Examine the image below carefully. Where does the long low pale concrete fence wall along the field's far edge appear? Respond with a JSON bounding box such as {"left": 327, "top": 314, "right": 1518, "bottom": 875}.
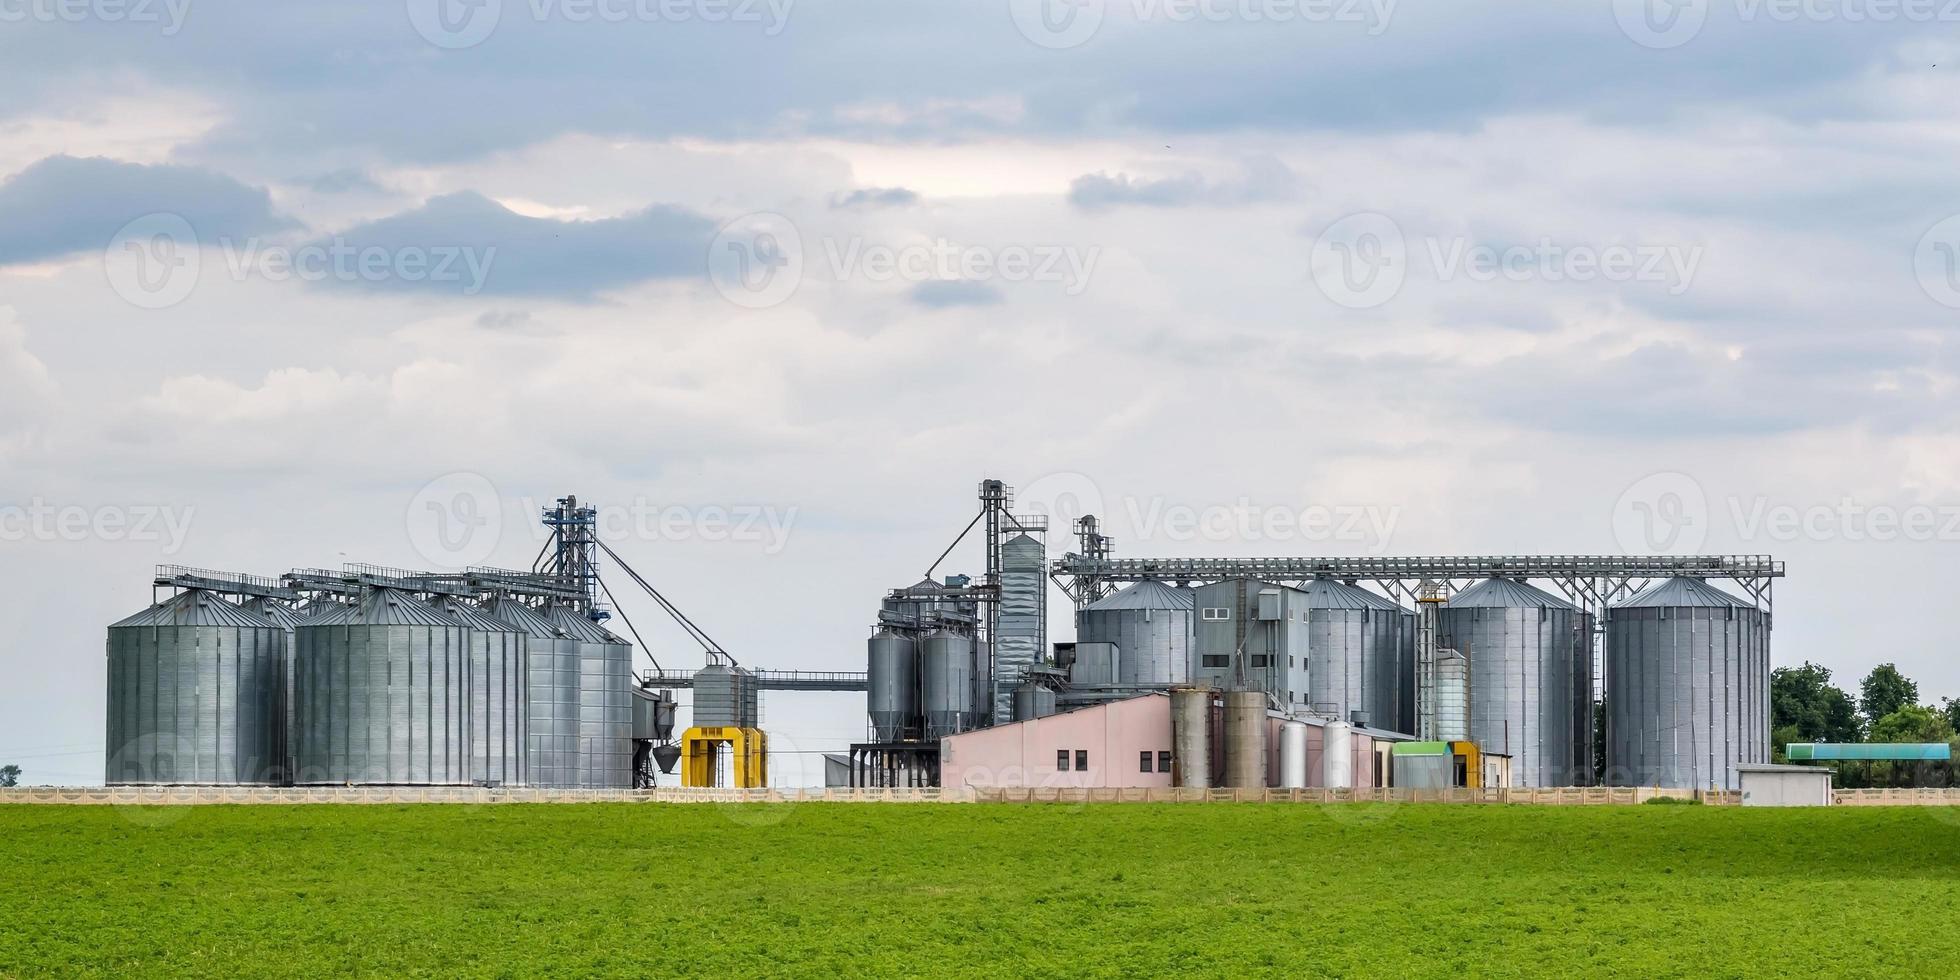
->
{"left": 0, "top": 786, "right": 1748, "bottom": 806}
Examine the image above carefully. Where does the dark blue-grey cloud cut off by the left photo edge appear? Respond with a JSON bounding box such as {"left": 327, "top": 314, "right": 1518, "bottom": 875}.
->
{"left": 0, "top": 157, "right": 288, "bottom": 265}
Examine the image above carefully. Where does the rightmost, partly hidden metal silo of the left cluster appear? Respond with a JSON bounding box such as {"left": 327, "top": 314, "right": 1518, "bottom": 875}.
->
{"left": 545, "top": 604, "right": 633, "bottom": 790}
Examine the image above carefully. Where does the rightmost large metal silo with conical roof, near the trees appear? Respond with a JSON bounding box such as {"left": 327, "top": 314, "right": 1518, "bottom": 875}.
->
{"left": 1605, "top": 578, "right": 1770, "bottom": 790}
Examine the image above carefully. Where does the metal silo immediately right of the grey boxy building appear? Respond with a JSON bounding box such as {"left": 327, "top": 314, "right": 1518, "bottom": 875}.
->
{"left": 1299, "top": 578, "right": 1413, "bottom": 731}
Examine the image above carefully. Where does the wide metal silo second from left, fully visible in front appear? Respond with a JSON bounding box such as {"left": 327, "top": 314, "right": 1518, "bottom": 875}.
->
{"left": 292, "top": 588, "right": 470, "bottom": 786}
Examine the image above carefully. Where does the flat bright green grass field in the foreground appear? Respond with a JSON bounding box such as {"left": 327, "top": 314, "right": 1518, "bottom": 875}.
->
{"left": 0, "top": 804, "right": 1960, "bottom": 976}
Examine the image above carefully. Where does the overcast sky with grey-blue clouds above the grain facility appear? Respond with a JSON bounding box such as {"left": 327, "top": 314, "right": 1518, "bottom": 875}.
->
{"left": 0, "top": 0, "right": 1960, "bottom": 784}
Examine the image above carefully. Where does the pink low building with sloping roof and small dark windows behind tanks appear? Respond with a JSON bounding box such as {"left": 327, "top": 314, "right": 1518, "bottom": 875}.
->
{"left": 939, "top": 694, "right": 1396, "bottom": 788}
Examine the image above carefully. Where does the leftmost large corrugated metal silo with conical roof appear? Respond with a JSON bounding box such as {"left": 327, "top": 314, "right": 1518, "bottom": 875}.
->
{"left": 104, "top": 590, "right": 286, "bottom": 786}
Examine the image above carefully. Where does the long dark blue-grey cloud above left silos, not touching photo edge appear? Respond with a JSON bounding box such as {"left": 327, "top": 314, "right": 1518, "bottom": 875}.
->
{"left": 317, "top": 192, "right": 715, "bottom": 300}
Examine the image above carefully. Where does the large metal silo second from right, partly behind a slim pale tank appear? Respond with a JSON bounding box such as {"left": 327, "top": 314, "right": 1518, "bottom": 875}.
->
{"left": 1441, "top": 578, "right": 1580, "bottom": 786}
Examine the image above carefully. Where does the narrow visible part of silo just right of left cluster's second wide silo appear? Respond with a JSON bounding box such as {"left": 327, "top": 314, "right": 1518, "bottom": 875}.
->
{"left": 433, "top": 598, "right": 531, "bottom": 786}
